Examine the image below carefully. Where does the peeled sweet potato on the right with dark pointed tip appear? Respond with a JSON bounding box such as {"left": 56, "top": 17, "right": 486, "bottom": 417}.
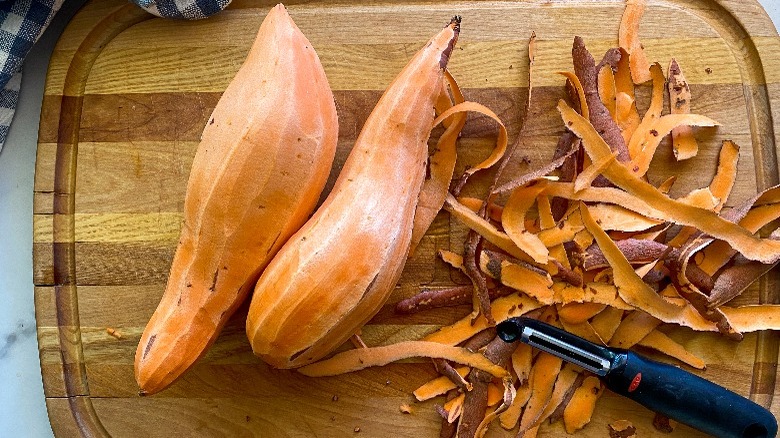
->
{"left": 247, "top": 17, "right": 460, "bottom": 368}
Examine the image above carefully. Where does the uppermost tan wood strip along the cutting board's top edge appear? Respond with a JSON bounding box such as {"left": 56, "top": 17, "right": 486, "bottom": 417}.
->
{"left": 80, "top": 1, "right": 718, "bottom": 49}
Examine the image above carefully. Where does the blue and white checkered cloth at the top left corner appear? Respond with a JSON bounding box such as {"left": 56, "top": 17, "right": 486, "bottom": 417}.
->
{"left": 0, "top": 0, "right": 230, "bottom": 150}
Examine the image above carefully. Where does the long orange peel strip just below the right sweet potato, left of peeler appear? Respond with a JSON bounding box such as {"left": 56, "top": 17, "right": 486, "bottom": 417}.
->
{"left": 298, "top": 341, "right": 509, "bottom": 378}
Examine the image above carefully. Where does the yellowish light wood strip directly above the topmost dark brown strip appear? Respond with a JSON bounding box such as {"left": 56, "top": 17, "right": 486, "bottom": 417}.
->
{"left": 65, "top": 37, "right": 742, "bottom": 94}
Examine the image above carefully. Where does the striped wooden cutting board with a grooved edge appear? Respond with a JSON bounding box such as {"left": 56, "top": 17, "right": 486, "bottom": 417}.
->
{"left": 33, "top": 0, "right": 780, "bottom": 437}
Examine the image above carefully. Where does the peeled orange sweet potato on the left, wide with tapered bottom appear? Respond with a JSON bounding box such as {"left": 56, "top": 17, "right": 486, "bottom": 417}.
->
{"left": 135, "top": 5, "right": 338, "bottom": 393}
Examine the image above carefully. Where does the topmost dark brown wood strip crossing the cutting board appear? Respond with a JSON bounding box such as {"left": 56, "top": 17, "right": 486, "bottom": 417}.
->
{"left": 39, "top": 84, "right": 748, "bottom": 142}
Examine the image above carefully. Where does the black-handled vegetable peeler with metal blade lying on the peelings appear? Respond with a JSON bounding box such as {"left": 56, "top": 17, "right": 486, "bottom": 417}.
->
{"left": 497, "top": 317, "right": 777, "bottom": 438}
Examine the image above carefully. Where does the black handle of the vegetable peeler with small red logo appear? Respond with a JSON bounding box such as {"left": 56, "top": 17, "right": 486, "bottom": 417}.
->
{"left": 602, "top": 349, "right": 777, "bottom": 438}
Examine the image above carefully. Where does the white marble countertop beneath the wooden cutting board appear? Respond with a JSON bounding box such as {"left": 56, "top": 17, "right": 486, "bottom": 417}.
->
{"left": 0, "top": 0, "right": 780, "bottom": 437}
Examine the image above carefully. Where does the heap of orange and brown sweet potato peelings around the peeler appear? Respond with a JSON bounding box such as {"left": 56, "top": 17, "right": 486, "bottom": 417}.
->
{"left": 301, "top": 2, "right": 780, "bottom": 437}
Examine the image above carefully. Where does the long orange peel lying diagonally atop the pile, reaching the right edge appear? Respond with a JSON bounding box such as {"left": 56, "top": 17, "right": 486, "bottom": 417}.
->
{"left": 548, "top": 101, "right": 780, "bottom": 264}
